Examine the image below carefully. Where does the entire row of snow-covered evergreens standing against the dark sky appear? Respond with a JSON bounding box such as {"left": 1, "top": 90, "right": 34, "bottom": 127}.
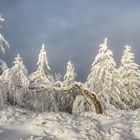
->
{"left": 0, "top": 15, "right": 140, "bottom": 109}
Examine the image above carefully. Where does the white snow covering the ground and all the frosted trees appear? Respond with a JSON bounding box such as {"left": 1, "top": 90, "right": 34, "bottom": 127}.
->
{"left": 0, "top": 14, "right": 140, "bottom": 140}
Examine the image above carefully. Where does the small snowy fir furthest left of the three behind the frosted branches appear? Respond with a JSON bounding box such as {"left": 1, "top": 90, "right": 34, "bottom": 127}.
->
{"left": 0, "top": 54, "right": 29, "bottom": 105}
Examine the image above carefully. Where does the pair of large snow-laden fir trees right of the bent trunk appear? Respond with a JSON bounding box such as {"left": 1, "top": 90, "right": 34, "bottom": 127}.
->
{"left": 86, "top": 39, "right": 140, "bottom": 109}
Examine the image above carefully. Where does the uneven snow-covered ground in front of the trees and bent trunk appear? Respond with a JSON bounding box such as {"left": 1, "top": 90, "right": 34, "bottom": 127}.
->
{"left": 0, "top": 107, "right": 140, "bottom": 140}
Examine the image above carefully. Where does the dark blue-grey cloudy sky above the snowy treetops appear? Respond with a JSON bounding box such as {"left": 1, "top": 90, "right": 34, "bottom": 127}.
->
{"left": 0, "top": 0, "right": 140, "bottom": 81}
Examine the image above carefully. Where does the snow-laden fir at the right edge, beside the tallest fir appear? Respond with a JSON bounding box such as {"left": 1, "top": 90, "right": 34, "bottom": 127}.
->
{"left": 119, "top": 46, "right": 140, "bottom": 108}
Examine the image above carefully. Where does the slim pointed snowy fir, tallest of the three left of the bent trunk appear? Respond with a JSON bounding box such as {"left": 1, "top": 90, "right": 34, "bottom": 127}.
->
{"left": 29, "top": 44, "right": 52, "bottom": 84}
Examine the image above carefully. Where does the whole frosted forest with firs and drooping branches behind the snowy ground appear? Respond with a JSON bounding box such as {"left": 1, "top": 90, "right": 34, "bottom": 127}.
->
{"left": 0, "top": 15, "right": 140, "bottom": 112}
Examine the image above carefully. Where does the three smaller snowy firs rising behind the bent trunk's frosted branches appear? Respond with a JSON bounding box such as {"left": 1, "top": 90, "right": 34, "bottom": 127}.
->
{"left": 0, "top": 44, "right": 76, "bottom": 89}
